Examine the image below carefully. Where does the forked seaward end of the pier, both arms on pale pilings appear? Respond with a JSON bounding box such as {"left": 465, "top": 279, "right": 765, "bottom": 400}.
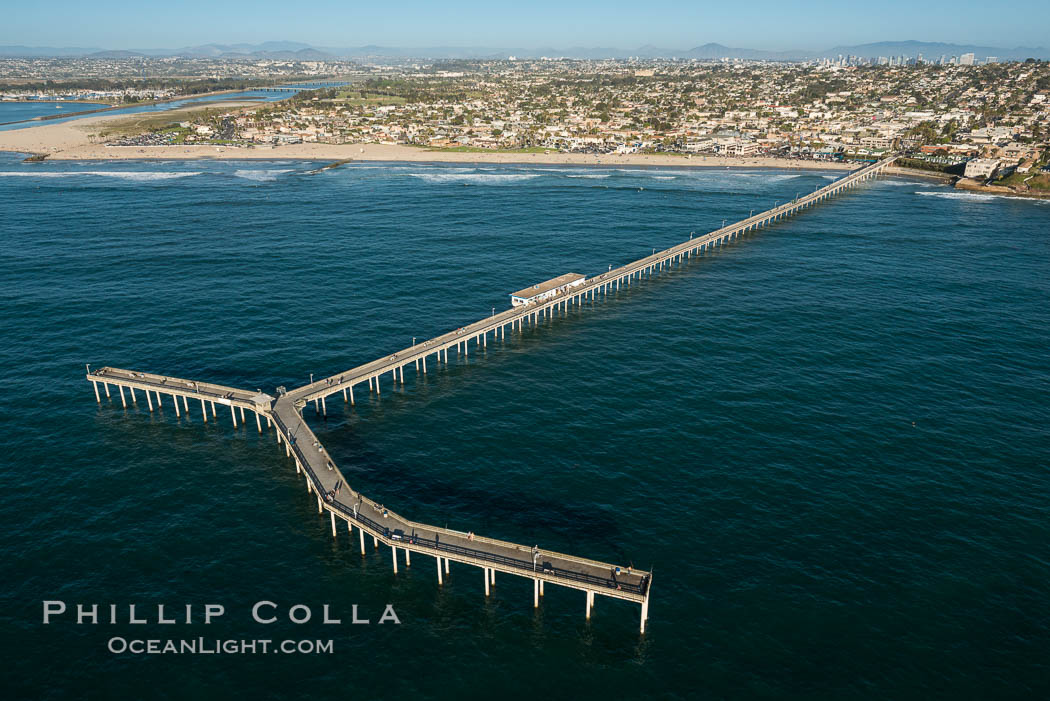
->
{"left": 86, "top": 367, "right": 652, "bottom": 632}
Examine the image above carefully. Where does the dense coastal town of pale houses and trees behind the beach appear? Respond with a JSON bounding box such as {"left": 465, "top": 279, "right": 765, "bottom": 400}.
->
{"left": 4, "top": 56, "right": 1050, "bottom": 193}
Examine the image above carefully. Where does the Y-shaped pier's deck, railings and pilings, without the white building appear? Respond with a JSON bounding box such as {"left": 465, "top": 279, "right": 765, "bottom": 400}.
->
{"left": 87, "top": 156, "right": 895, "bottom": 633}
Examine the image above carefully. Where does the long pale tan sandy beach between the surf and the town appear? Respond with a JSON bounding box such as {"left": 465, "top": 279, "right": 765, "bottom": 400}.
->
{"left": 0, "top": 103, "right": 865, "bottom": 170}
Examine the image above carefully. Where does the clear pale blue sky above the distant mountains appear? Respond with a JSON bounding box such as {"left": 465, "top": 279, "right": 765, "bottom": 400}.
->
{"left": 8, "top": 0, "right": 1050, "bottom": 50}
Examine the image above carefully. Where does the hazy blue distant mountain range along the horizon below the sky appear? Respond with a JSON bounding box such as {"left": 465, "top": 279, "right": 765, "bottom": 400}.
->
{"left": 0, "top": 41, "right": 1050, "bottom": 61}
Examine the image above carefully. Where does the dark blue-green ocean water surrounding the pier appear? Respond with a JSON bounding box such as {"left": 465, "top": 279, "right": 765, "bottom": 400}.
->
{"left": 0, "top": 154, "right": 1050, "bottom": 699}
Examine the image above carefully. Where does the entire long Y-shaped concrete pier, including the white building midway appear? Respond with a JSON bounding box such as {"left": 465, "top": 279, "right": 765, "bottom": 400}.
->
{"left": 86, "top": 156, "right": 896, "bottom": 633}
